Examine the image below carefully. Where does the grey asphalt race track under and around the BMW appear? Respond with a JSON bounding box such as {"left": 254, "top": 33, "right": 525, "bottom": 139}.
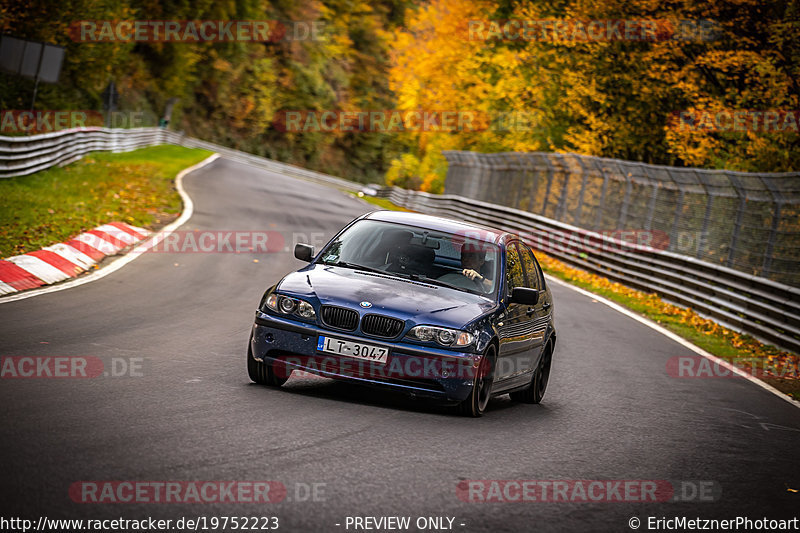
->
{"left": 0, "top": 156, "right": 800, "bottom": 532}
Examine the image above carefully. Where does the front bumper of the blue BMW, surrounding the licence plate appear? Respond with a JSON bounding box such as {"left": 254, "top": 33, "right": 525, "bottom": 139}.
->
{"left": 250, "top": 311, "right": 480, "bottom": 403}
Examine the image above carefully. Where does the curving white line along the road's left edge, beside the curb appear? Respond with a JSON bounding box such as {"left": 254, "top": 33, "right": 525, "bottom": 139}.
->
{"left": 0, "top": 154, "right": 219, "bottom": 304}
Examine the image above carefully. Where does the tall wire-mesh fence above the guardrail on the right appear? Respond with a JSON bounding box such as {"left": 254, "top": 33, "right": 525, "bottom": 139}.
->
{"left": 443, "top": 151, "right": 800, "bottom": 286}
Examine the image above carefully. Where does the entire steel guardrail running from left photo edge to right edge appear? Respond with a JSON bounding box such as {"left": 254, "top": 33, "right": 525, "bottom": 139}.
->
{"left": 0, "top": 128, "right": 800, "bottom": 353}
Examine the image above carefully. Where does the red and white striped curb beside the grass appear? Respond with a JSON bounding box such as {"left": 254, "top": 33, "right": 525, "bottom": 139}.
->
{"left": 0, "top": 222, "right": 151, "bottom": 295}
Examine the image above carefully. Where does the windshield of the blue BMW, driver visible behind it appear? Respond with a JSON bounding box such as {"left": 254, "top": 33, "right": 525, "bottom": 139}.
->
{"left": 319, "top": 220, "right": 500, "bottom": 295}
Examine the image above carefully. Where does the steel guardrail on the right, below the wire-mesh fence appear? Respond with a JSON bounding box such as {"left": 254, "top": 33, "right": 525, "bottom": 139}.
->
{"left": 378, "top": 187, "right": 800, "bottom": 353}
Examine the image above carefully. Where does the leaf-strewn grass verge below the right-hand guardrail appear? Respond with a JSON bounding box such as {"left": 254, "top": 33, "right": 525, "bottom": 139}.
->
{"left": 363, "top": 191, "right": 800, "bottom": 400}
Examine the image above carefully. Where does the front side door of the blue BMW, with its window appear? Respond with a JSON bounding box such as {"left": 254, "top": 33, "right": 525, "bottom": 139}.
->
{"left": 495, "top": 242, "right": 536, "bottom": 381}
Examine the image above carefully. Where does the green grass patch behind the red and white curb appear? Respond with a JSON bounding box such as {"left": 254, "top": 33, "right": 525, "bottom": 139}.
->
{"left": 0, "top": 145, "right": 211, "bottom": 257}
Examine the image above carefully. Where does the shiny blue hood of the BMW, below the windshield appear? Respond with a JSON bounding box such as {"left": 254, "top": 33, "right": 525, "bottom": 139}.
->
{"left": 277, "top": 265, "right": 497, "bottom": 328}
